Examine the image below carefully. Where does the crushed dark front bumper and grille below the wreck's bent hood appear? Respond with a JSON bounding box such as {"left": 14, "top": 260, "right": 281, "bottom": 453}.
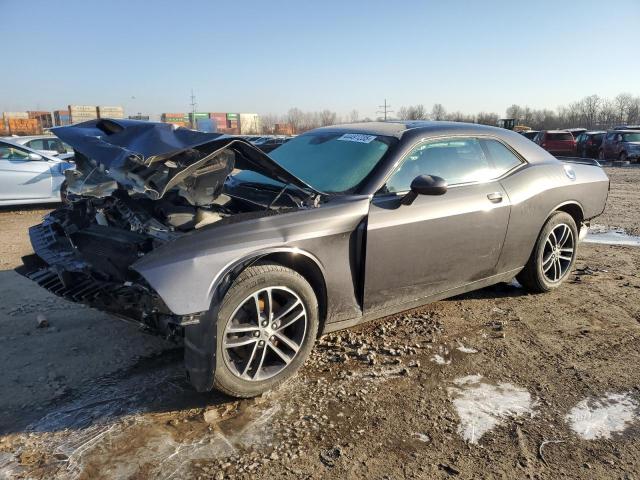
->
{"left": 18, "top": 202, "right": 198, "bottom": 335}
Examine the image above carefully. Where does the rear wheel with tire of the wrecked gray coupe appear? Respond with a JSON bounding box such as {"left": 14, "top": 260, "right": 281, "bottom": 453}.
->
{"left": 516, "top": 212, "right": 578, "bottom": 293}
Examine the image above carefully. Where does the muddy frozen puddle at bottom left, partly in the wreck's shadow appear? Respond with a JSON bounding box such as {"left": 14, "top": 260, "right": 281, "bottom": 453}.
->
{"left": 0, "top": 348, "right": 279, "bottom": 479}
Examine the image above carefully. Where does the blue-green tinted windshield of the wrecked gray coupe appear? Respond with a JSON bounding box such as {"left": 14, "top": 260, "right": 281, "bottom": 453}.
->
{"left": 234, "top": 132, "right": 395, "bottom": 193}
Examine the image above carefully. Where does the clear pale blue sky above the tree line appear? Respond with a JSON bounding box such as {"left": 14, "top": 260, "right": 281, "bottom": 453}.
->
{"left": 0, "top": 0, "right": 640, "bottom": 117}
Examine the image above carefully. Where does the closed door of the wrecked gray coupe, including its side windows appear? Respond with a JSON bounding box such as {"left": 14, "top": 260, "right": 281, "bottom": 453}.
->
{"left": 364, "top": 137, "right": 522, "bottom": 313}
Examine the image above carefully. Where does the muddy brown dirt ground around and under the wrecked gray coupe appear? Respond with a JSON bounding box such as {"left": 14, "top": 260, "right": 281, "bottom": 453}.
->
{"left": 0, "top": 168, "right": 640, "bottom": 479}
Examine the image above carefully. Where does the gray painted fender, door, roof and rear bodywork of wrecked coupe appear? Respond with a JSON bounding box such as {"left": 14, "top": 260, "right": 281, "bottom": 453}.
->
{"left": 132, "top": 122, "right": 609, "bottom": 329}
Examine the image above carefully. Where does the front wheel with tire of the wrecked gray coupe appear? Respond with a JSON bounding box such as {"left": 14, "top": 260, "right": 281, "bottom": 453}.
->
{"left": 214, "top": 264, "right": 318, "bottom": 397}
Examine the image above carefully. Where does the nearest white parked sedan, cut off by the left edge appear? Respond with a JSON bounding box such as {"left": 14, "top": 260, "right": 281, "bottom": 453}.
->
{"left": 0, "top": 140, "right": 73, "bottom": 205}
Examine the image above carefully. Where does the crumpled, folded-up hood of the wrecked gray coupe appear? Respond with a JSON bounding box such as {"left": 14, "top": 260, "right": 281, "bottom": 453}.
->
{"left": 52, "top": 119, "right": 313, "bottom": 200}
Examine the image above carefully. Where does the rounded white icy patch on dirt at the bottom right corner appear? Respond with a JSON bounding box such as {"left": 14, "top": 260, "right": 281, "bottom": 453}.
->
{"left": 565, "top": 393, "right": 640, "bottom": 440}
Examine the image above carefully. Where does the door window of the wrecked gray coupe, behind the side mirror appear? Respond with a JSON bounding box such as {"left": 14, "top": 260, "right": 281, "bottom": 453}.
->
{"left": 384, "top": 137, "right": 496, "bottom": 192}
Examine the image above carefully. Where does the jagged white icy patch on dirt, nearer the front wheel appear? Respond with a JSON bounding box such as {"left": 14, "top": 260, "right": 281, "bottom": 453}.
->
{"left": 447, "top": 375, "right": 535, "bottom": 443}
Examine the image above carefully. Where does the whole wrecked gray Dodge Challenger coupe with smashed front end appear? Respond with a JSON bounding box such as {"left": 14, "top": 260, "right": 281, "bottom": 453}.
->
{"left": 21, "top": 120, "right": 609, "bottom": 397}
